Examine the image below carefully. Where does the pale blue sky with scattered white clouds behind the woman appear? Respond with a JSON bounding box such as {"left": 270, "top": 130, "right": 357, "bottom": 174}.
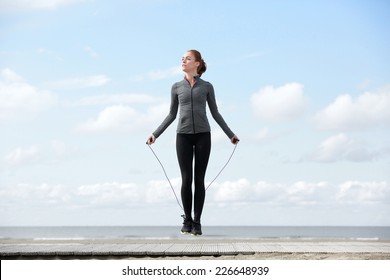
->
{"left": 0, "top": 0, "right": 390, "bottom": 226}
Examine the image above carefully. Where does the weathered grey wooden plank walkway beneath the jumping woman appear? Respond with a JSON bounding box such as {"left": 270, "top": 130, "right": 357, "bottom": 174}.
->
{"left": 0, "top": 240, "right": 390, "bottom": 258}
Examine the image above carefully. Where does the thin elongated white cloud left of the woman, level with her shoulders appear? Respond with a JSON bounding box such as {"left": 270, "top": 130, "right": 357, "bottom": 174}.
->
{"left": 47, "top": 75, "right": 111, "bottom": 89}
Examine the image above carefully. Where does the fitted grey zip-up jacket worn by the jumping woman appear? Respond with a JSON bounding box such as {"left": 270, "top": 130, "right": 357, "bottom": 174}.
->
{"left": 153, "top": 77, "right": 234, "bottom": 139}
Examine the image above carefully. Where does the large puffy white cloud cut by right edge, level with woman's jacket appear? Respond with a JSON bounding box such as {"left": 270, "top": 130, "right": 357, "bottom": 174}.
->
{"left": 314, "top": 86, "right": 390, "bottom": 130}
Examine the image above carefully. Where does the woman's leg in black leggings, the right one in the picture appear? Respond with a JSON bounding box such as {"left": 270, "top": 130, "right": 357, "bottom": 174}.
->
{"left": 194, "top": 132, "right": 211, "bottom": 223}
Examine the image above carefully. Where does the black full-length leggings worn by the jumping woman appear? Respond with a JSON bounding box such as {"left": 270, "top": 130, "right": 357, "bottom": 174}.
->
{"left": 176, "top": 132, "right": 211, "bottom": 222}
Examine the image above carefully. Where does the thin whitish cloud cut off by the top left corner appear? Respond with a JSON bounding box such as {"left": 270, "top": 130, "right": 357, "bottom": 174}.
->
{"left": 0, "top": 0, "right": 86, "bottom": 11}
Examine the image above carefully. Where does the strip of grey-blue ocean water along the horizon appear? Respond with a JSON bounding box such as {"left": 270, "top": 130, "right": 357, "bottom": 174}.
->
{"left": 0, "top": 226, "right": 390, "bottom": 242}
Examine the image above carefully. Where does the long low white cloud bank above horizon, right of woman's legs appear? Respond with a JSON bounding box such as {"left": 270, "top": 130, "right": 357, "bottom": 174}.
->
{"left": 212, "top": 179, "right": 390, "bottom": 207}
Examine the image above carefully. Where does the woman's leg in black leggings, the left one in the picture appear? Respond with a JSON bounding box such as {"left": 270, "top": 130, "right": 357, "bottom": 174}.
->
{"left": 176, "top": 133, "right": 194, "bottom": 221}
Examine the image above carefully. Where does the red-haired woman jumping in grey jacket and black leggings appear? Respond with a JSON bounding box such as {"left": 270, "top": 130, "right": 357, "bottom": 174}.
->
{"left": 148, "top": 50, "right": 239, "bottom": 235}
